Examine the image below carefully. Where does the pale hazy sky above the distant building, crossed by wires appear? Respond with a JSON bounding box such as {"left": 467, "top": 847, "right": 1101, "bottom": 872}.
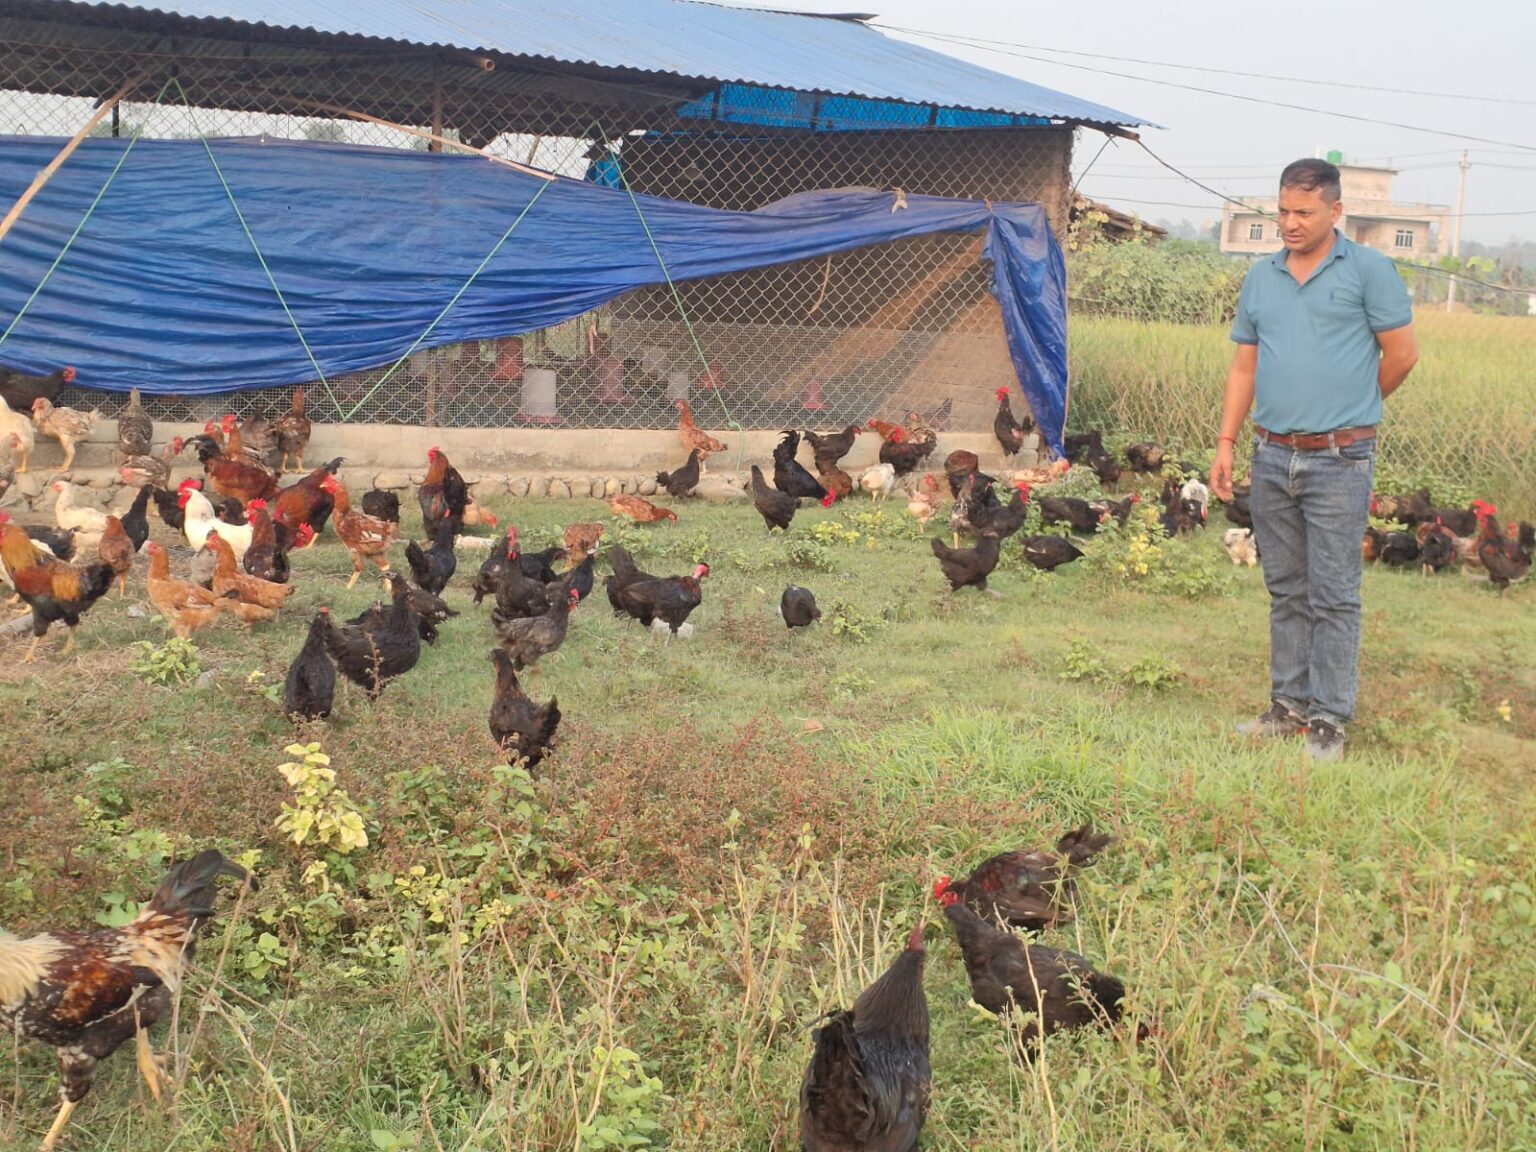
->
{"left": 754, "top": 0, "right": 1536, "bottom": 243}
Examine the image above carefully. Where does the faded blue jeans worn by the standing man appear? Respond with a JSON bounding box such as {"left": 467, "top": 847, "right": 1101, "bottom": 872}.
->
{"left": 1249, "top": 439, "right": 1376, "bottom": 728}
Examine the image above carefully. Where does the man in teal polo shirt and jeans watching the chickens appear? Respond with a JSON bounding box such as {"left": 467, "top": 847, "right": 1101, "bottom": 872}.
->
{"left": 1210, "top": 160, "right": 1419, "bottom": 760}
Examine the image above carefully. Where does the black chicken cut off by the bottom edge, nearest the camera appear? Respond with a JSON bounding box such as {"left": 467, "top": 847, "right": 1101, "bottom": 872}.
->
{"left": 800, "top": 923, "right": 932, "bottom": 1152}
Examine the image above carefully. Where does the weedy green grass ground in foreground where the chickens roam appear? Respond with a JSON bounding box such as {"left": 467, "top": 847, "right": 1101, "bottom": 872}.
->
{"left": 0, "top": 501, "right": 1536, "bottom": 1152}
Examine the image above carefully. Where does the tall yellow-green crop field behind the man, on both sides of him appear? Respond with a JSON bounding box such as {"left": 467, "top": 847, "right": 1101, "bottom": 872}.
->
{"left": 1069, "top": 309, "right": 1536, "bottom": 518}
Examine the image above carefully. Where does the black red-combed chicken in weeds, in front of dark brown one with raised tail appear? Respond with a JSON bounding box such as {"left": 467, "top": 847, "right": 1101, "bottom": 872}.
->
{"left": 942, "top": 892, "right": 1126, "bottom": 1054}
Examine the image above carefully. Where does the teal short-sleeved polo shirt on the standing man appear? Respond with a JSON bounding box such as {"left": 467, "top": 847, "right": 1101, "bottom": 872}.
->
{"left": 1232, "top": 230, "right": 1413, "bottom": 433}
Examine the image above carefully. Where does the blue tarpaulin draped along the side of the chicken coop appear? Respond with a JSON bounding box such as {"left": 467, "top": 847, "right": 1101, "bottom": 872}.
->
{"left": 0, "top": 137, "right": 1066, "bottom": 450}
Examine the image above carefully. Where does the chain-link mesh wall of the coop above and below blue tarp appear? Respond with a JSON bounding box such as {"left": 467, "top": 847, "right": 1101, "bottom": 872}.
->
{"left": 0, "top": 0, "right": 1072, "bottom": 432}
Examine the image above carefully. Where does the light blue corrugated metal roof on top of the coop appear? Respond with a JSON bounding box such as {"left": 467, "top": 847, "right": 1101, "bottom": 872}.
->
{"left": 77, "top": 0, "right": 1149, "bottom": 126}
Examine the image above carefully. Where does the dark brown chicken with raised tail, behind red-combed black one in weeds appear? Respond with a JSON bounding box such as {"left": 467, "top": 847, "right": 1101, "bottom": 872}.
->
{"left": 934, "top": 823, "right": 1112, "bottom": 932}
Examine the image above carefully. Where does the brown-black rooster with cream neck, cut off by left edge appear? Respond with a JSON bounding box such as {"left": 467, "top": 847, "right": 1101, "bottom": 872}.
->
{"left": 0, "top": 849, "right": 250, "bottom": 1149}
